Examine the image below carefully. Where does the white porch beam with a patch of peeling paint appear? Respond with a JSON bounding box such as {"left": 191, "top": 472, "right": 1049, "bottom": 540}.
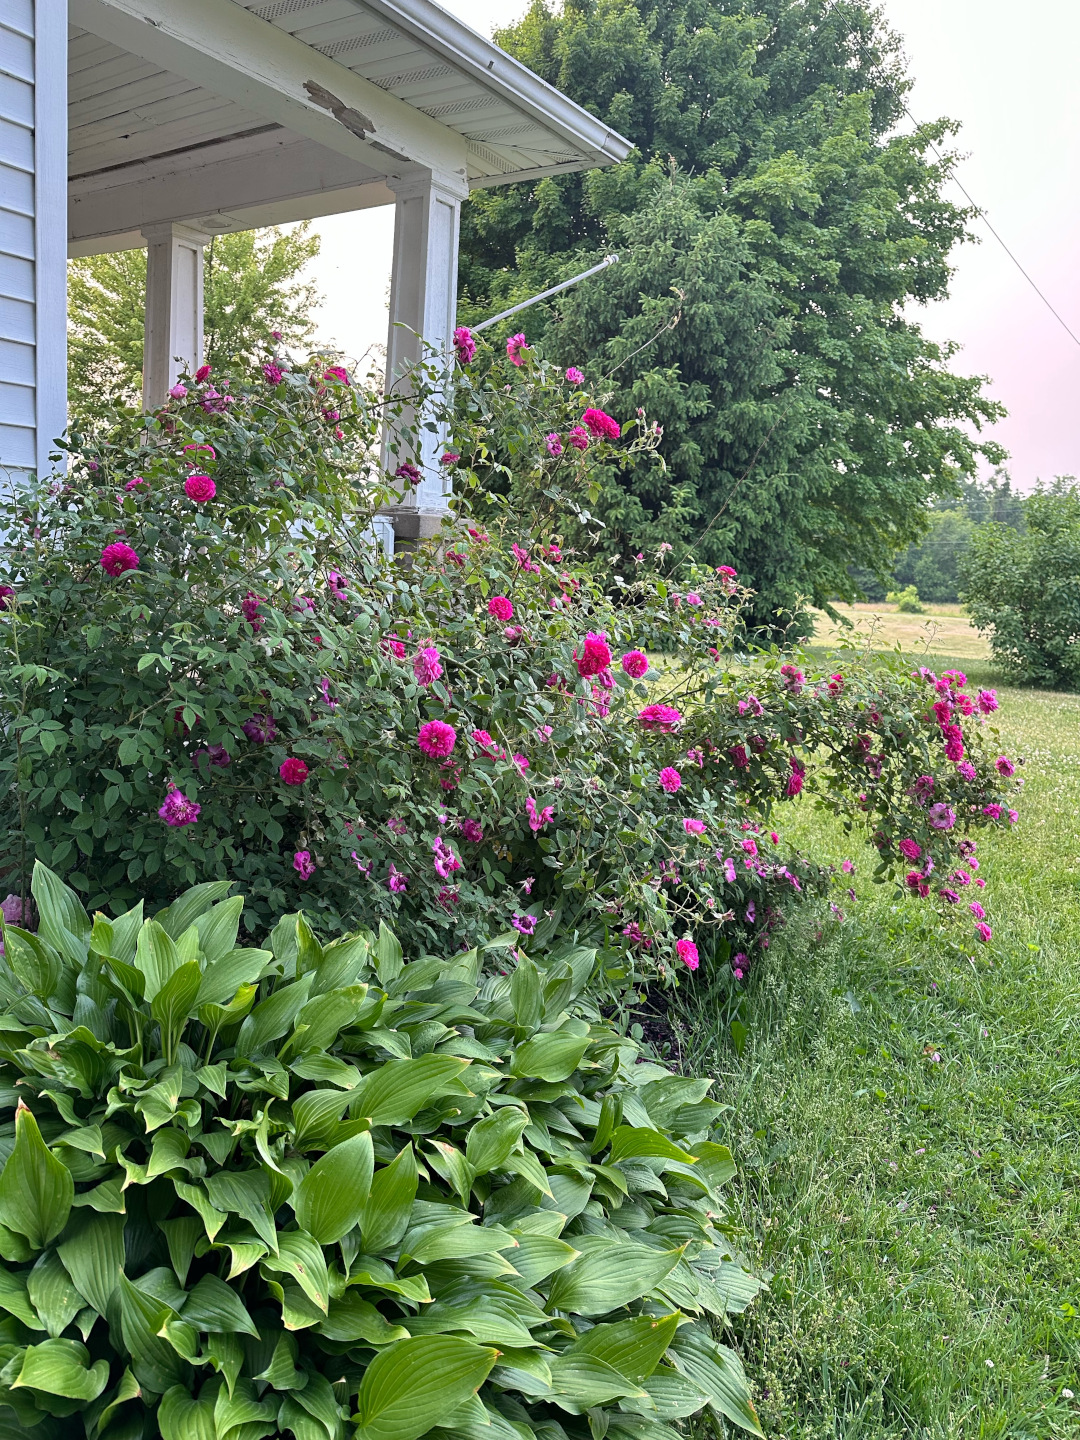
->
{"left": 71, "top": 0, "right": 467, "bottom": 190}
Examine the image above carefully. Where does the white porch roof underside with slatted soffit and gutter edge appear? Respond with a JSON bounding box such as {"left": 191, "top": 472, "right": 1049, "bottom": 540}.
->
{"left": 69, "top": 0, "right": 631, "bottom": 253}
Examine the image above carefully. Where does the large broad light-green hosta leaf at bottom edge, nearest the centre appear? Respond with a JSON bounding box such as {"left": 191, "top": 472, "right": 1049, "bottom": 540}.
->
{"left": 354, "top": 1335, "right": 498, "bottom": 1440}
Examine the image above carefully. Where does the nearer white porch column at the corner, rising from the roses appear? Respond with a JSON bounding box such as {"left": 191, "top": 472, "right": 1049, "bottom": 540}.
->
{"left": 383, "top": 173, "right": 468, "bottom": 541}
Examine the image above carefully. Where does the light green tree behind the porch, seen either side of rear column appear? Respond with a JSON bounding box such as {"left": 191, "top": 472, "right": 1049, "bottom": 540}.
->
{"left": 68, "top": 223, "right": 320, "bottom": 408}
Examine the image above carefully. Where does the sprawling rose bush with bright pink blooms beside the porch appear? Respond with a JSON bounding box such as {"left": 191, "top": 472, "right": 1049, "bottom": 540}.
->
{"left": 0, "top": 341, "right": 1017, "bottom": 978}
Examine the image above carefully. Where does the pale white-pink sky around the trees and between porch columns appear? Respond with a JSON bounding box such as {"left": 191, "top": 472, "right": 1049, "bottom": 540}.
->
{"left": 305, "top": 0, "right": 1080, "bottom": 490}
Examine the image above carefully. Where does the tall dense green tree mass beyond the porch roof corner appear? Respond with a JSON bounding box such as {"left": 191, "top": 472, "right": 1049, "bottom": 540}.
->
{"left": 461, "top": 0, "right": 1002, "bottom": 624}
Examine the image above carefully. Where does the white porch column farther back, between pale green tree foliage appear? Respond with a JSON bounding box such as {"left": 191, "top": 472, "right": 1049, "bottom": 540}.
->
{"left": 143, "top": 225, "right": 210, "bottom": 410}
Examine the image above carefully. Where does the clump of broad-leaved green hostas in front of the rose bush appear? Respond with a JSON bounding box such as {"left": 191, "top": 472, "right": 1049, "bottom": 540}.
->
{"left": 0, "top": 867, "right": 760, "bottom": 1440}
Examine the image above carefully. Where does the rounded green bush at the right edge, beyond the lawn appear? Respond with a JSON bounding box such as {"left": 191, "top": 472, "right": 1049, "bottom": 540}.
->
{"left": 962, "top": 480, "right": 1080, "bottom": 690}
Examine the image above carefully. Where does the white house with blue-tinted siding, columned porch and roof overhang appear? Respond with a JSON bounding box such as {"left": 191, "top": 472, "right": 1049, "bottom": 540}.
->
{"left": 0, "top": 0, "right": 631, "bottom": 533}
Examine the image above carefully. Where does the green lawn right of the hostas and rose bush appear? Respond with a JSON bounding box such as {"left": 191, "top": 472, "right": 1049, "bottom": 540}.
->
{"left": 678, "top": 657, "right": 1080, "bottom": 1440}
